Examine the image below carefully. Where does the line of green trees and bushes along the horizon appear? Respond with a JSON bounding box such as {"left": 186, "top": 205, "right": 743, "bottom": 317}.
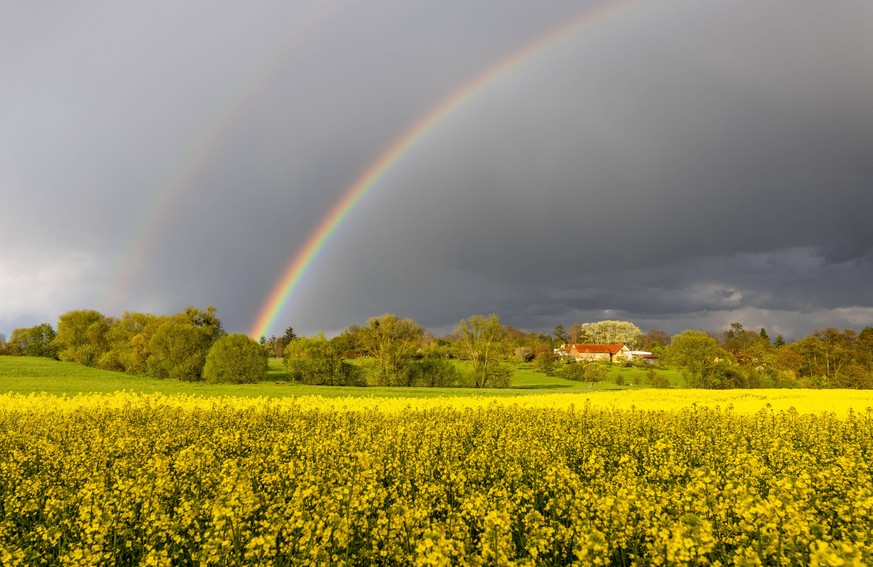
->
{"left": 0, "top": 307, "right": 873, "bottom": 388}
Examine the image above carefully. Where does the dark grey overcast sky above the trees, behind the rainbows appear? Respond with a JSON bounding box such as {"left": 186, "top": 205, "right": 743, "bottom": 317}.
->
{"left": 0, "top": 0, "right": 873, "bottom": 338}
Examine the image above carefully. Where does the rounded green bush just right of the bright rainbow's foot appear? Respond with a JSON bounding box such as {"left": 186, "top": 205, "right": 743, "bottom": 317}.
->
{"left": 285, "top": 334, "right": 364, "bottom": 386}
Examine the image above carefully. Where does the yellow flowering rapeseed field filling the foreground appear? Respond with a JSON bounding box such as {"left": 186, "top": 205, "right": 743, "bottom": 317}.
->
{"left": 0, "top": 390, "right": 873, "bottom": 566}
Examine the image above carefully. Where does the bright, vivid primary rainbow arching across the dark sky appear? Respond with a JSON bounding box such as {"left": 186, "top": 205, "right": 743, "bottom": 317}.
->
{"left": 249, "top": 0, "right": 633, "bottom": 339}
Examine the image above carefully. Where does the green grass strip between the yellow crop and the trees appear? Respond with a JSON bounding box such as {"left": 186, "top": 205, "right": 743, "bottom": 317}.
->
{"left": 0, "top": 356, "right": 684, "bottom": 397}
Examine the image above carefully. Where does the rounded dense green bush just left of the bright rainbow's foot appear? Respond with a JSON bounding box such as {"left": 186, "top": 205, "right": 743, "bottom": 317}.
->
{"left": 203, "top": 334, "right": 267, "bottom": 384}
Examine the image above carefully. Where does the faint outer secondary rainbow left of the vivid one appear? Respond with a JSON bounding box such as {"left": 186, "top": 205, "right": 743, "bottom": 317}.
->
{"left": 102, "top": 0, "right": 339, "bottom": 312}
